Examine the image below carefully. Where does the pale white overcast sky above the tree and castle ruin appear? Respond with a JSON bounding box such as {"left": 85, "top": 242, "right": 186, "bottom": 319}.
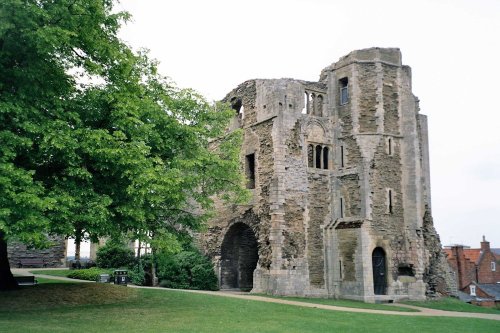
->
{"left": 113, "top": 0, "right": 500, "bottom": 247}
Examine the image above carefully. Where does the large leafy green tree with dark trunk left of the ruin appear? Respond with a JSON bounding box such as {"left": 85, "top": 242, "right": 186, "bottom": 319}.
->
{"left": 0, "top": 0, "right": 245, "bottom": 289}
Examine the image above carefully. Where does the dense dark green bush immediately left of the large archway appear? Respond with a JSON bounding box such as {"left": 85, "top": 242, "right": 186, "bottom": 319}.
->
{"left": 157, "top": 251, "right": 218, "bottom": 290}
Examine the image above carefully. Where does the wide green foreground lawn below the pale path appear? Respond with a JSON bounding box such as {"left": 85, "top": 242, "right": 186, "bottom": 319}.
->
{"left": 0, "top": 283, "right": 500, "bottom": 333}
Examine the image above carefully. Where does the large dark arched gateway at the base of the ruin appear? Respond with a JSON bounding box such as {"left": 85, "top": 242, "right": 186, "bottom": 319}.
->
{"left": 220, "top": 222, "right": 259, "bottom": 291}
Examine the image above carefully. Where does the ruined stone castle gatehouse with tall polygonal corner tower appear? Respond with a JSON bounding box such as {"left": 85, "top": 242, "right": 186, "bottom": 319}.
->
{"left": 200, "top": 48, "right": 443, "bottom": 302}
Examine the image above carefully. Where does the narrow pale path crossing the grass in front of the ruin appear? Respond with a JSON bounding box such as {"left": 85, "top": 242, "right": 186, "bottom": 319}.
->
{"left": 18, "top": 269, "right": 500, "bottom": 321}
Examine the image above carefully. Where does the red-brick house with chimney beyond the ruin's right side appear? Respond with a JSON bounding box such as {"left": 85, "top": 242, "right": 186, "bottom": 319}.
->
{"left": 444, "top": 236, "right": 500, "bottom": 302}
